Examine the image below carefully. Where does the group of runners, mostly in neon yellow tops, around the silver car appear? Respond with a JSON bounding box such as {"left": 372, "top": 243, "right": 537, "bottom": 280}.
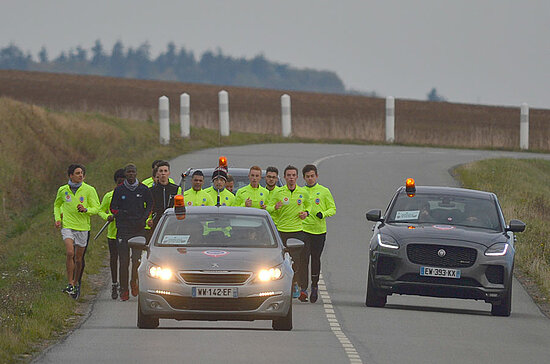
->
{"left": 54, "top": 160, "right": 336, "bottom": 303}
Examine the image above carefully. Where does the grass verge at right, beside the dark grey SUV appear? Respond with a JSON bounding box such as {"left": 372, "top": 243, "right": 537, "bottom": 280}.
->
{"left": 454, "top": 158, "right": 550, "bottom": 303}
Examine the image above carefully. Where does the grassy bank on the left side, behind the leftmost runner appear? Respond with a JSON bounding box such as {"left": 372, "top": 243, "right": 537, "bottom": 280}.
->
{"left": 0, "top": 98, "right": 308, "bottom": 363}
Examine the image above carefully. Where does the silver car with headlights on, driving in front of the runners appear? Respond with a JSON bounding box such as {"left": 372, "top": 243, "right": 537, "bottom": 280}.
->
{"left": 130, "top": 206, "right": 303, "bottom": 330}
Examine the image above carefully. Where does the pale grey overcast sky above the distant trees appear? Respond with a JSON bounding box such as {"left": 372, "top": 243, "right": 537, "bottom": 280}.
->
{"left": 0, "top": 0, "right": 550, "bottom": 109}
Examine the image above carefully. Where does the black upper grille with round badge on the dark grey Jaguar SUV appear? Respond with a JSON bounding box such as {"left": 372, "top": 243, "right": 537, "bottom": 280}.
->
{"left": 407, "top": 244, "right": 477, "bottom": 268}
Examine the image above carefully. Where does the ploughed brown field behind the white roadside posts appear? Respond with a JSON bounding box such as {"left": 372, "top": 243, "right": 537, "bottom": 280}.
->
{"left": 0, "top": 70, "right": 550, "bottom": 151}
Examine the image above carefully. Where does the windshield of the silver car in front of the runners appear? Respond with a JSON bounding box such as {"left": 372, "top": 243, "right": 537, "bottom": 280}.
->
{"left": 155, "top": 214, "right": 277, "bottom": 248}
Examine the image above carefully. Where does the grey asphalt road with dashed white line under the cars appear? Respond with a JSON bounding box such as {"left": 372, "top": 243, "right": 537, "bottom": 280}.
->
{"left": 36, "top": 144, "right": 550, "bottom": 364}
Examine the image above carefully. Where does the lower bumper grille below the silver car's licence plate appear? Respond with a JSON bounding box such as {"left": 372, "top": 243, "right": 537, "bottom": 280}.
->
{"left": 161, "top": 295, "right": 269, "bottom": 311}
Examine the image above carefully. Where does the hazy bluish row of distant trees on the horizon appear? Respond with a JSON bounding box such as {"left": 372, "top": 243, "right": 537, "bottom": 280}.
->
{"left": 0, "top": 40, "right": 346, "bottom": 93}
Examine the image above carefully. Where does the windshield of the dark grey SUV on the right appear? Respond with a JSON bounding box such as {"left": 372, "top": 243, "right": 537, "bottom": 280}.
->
{"left": 386, "top": 193, "right": 501, "bottom": 231}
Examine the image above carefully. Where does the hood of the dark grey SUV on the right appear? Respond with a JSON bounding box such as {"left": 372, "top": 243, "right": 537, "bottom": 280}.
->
{"left": 379, "top": 224, "right": 507, "bottom": 247}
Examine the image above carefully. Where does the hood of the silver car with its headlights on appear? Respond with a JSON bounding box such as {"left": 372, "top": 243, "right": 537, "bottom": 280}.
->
{"left": 148, "top": 247, "right": 283, "bottom": 272}
